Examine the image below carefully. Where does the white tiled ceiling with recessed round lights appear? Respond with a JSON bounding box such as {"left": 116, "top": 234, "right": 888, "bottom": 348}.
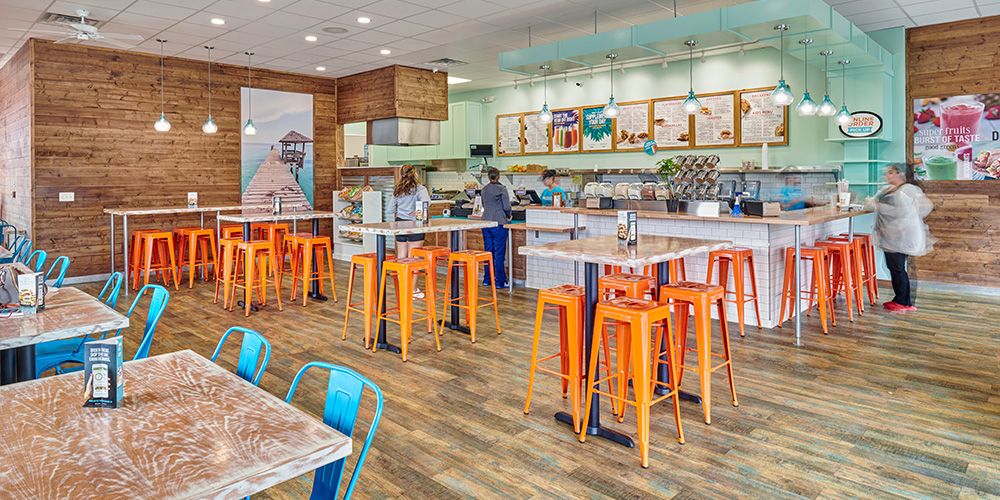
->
{"left": 0, "top": 0, "right": 1000, "bottom": 90}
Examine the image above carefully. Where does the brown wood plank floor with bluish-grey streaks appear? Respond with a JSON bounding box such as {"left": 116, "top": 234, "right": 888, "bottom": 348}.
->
{"left": 72, "top": 263, "right": 1000, "bottom": 498}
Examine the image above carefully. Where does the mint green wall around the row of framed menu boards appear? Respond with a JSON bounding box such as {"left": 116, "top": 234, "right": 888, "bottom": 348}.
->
{"left": 449, "top": 47, "right": 843, "bottom": 168}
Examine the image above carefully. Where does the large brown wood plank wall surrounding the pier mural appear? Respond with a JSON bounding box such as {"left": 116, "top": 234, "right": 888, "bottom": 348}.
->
{"left": 29, "top": 40, "right": 343, "bottom": 276}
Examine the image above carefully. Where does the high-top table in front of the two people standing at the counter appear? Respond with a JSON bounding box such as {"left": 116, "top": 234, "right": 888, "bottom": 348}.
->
{"left": 344, "top": 218, "right": 497, "bottom": 354}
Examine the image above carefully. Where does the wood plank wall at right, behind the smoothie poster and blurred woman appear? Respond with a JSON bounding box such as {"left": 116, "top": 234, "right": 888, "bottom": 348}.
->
{"left": 906, "top": 16, "right": 1000, "bottom": 287}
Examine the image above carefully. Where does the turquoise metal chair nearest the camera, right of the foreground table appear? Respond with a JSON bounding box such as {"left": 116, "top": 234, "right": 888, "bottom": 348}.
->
{"left": 285, "top": 361, "right": 384, "bottom": 498}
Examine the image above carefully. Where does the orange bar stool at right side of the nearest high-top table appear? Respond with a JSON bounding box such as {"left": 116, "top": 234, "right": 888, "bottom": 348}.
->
{"left": 660, "top": 281, "right": 740, "bottom": 424}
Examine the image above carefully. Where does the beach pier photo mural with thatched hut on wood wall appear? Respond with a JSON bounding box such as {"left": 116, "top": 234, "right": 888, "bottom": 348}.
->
{"left": 240, "top": 87, "right": 313, "bottom": 210}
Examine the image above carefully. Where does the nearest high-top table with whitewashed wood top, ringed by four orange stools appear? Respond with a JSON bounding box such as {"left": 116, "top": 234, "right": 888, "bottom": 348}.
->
{"left": 518, "top": 235, "right": 732, "bottom": 448}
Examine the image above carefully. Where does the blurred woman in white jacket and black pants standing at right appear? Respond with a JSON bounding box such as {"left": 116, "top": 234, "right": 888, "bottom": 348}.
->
{"left": 869, "top": 164, "right": 934, "bottom": 312}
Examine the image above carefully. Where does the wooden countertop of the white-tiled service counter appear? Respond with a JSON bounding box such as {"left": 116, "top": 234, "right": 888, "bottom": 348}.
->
{"left": 530, "top": 206, "right": 872, "bottom": 226}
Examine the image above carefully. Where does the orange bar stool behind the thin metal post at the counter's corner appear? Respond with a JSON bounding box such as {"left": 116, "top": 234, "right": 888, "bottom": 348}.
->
{"left": 778, "top": 247, "right": 837, "bottom": 334}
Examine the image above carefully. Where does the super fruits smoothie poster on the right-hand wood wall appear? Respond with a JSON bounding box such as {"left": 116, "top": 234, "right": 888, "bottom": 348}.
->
{"left": 913, "top": 94, "right": 1000, "bottom": 180}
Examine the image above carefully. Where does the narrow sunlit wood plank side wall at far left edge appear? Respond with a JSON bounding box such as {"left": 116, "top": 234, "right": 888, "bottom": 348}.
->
{"left": 0, "top": 45, "right": 32, "bottom": 235}
